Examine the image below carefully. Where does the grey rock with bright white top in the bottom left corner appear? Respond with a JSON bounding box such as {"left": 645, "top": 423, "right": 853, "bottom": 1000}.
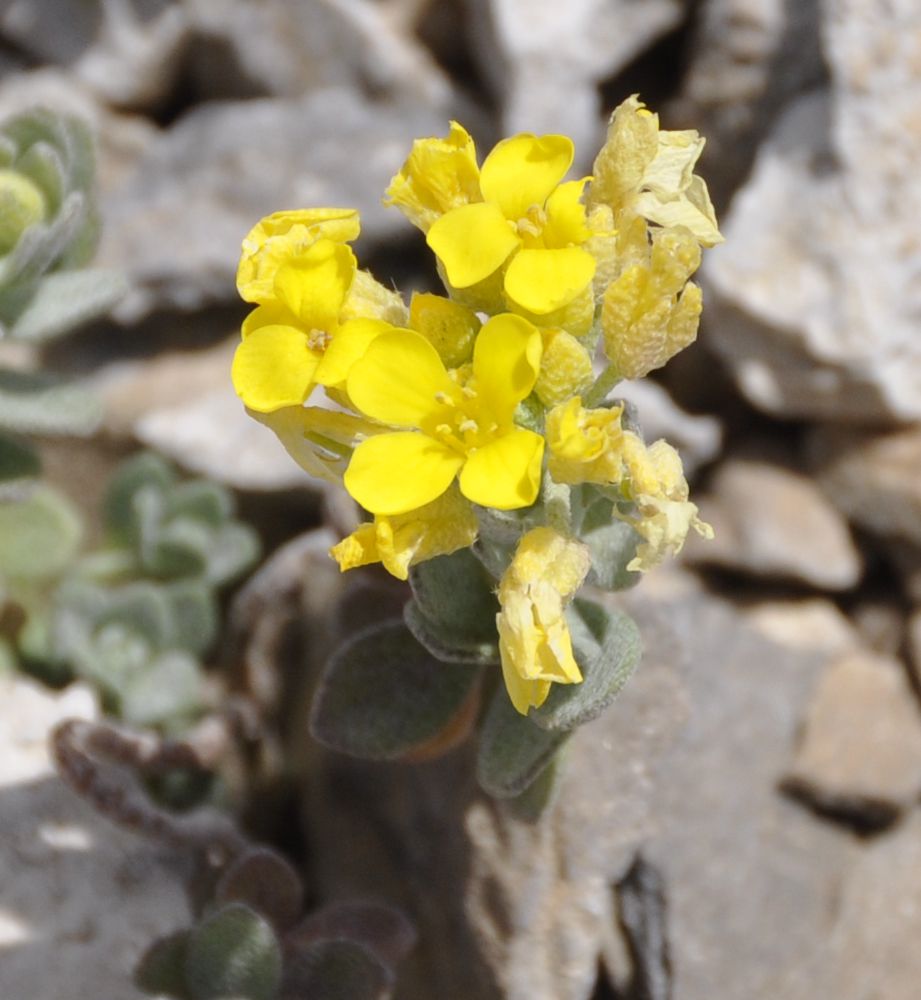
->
{"left": 0, "top": 677, "right": 189, "bottom": 1000}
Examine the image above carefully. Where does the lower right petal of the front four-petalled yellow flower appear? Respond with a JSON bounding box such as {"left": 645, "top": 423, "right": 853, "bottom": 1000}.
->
{"left": 460, "top": 428, "right": 544, "bottom": 510}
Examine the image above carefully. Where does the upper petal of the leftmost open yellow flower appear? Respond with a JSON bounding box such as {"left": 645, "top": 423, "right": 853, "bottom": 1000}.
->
{"left": 275, "top": 240, "right": 356, "bottom": 330}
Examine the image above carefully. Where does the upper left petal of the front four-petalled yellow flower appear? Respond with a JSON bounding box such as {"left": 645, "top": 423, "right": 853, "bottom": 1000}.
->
{"left": 346, "top": 330, "right": 454, "bottom": 424}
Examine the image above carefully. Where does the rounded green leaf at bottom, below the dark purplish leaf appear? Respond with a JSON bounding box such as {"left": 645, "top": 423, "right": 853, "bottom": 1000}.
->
{"left": 185, "top": 903, "right": 281, "bottom": 1000}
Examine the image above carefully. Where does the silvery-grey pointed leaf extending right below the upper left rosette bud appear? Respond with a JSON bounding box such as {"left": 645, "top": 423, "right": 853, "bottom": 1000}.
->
{"left": 10, "top": 270, "right": 128, "bottom": 343}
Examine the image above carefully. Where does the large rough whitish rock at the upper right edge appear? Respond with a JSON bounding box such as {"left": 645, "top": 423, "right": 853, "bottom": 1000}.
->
{"left": 705, "top": 0, "right": 921, "bottom": 422}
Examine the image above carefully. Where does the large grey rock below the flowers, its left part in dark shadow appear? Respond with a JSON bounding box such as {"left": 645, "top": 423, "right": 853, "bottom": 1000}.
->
{"left": 304, "top": 581, "right": 851, "bottom": 1000}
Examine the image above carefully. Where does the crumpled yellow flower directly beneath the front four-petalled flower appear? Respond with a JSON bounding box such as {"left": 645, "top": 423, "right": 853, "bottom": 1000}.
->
{"left": 330, "top": 487, "right": 477, "bottom": 580}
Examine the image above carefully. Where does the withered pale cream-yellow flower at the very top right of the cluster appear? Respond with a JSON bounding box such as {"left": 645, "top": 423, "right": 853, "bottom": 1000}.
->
{"left": 588, "top": 94, "right": 723, "bottom": 246}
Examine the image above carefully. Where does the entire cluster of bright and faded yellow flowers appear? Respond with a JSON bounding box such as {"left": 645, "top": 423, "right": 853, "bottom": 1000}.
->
{"left": 233, "top": 97, "right": 721, "bottom": 714}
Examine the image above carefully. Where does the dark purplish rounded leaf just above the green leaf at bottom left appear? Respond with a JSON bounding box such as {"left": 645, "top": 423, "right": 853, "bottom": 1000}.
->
{"left": 214, "top": 847, "right": 304, "bottom": 931}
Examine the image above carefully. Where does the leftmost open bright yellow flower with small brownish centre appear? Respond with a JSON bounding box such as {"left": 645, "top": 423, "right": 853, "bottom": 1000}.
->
{"left": 232, "top": 239, "right": 395, "bottom": 413}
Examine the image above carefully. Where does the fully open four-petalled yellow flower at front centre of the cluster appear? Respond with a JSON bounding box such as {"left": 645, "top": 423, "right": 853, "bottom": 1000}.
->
{"left": 345, "top": 314, "right": 544, "bottom": 515}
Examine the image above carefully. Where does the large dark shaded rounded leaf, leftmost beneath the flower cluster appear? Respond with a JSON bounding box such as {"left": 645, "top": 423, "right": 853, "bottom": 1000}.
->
{"left": 310, "top": 622, "right": 478, "bottom": 760}
